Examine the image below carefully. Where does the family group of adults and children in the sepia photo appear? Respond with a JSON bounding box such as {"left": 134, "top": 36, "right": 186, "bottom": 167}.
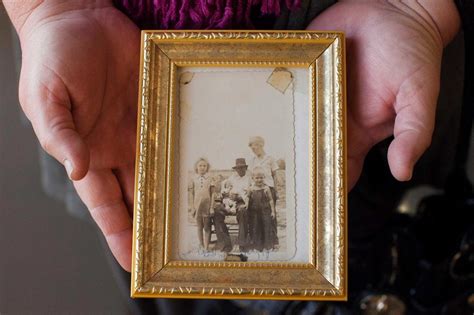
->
{"left": 188, "top": 136, "right": 278, "bottom": 252}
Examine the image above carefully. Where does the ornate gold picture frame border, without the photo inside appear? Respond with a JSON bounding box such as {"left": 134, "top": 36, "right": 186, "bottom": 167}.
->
{"left": 131, "top": 31, "right": 347, "bottom": 300}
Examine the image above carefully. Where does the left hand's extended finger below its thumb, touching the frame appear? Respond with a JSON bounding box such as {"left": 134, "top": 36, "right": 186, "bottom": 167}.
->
{"left": 74, "top": 170, "right": 132, "bottom": 271}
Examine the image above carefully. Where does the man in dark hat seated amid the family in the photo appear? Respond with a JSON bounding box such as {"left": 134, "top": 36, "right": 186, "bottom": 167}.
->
{"left": 222, "top": 158, "right": 252, "bottom": 251}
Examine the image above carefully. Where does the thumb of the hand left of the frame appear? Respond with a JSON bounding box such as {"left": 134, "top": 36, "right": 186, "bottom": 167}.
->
{"left": 20, "top": 65, "right": 89, "bottom": 180}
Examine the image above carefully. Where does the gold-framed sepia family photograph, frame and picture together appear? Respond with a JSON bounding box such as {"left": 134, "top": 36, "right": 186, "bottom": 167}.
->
{"left": 131, "top": 31, "right": 347, "bottom": 300}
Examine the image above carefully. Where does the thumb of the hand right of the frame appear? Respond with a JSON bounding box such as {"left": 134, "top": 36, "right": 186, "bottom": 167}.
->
{"left": 388, "top": 73, "right": 439, "bottom": 181}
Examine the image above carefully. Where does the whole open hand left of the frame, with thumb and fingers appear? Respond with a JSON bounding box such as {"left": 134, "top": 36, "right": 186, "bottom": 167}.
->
{"left": 5, "top": 1, "right": 140, "bottom": 271}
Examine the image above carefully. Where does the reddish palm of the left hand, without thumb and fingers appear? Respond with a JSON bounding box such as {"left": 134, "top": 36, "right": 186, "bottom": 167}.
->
{"left": 24, "top": 8, "right": 139, "bottom": 169}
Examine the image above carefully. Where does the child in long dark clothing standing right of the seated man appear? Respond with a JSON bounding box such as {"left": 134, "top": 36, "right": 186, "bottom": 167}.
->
{"left": 248, "top": 167, "right": 278, "bottom": 251}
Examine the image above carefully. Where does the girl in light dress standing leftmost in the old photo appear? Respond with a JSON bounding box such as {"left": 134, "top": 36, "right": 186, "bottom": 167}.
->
{"left": 188, "top": 158, "right": 214, "bottom": 251}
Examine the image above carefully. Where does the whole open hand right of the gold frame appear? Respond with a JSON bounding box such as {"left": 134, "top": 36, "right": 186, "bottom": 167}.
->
{"left": 308, "top": 0, "right": 459, "bottom": 188}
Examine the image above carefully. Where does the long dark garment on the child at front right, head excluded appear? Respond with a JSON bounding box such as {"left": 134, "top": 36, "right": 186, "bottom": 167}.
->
{"left": 248, "top": 188, "right": 278, "bottom": 251}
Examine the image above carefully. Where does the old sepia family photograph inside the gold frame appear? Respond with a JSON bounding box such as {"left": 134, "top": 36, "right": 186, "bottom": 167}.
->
{"left": 172, "top": 67, "right": 307, "bottom": 261}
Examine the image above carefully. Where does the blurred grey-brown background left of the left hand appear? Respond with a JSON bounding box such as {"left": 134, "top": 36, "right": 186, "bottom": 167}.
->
{"left": 0, "top": 4, "right": 128, "bottom": 314}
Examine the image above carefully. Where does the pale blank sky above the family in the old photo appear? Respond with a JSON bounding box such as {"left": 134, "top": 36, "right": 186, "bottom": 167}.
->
{"left": 179, "top": 68, "right": 294, "bottom": 169}
